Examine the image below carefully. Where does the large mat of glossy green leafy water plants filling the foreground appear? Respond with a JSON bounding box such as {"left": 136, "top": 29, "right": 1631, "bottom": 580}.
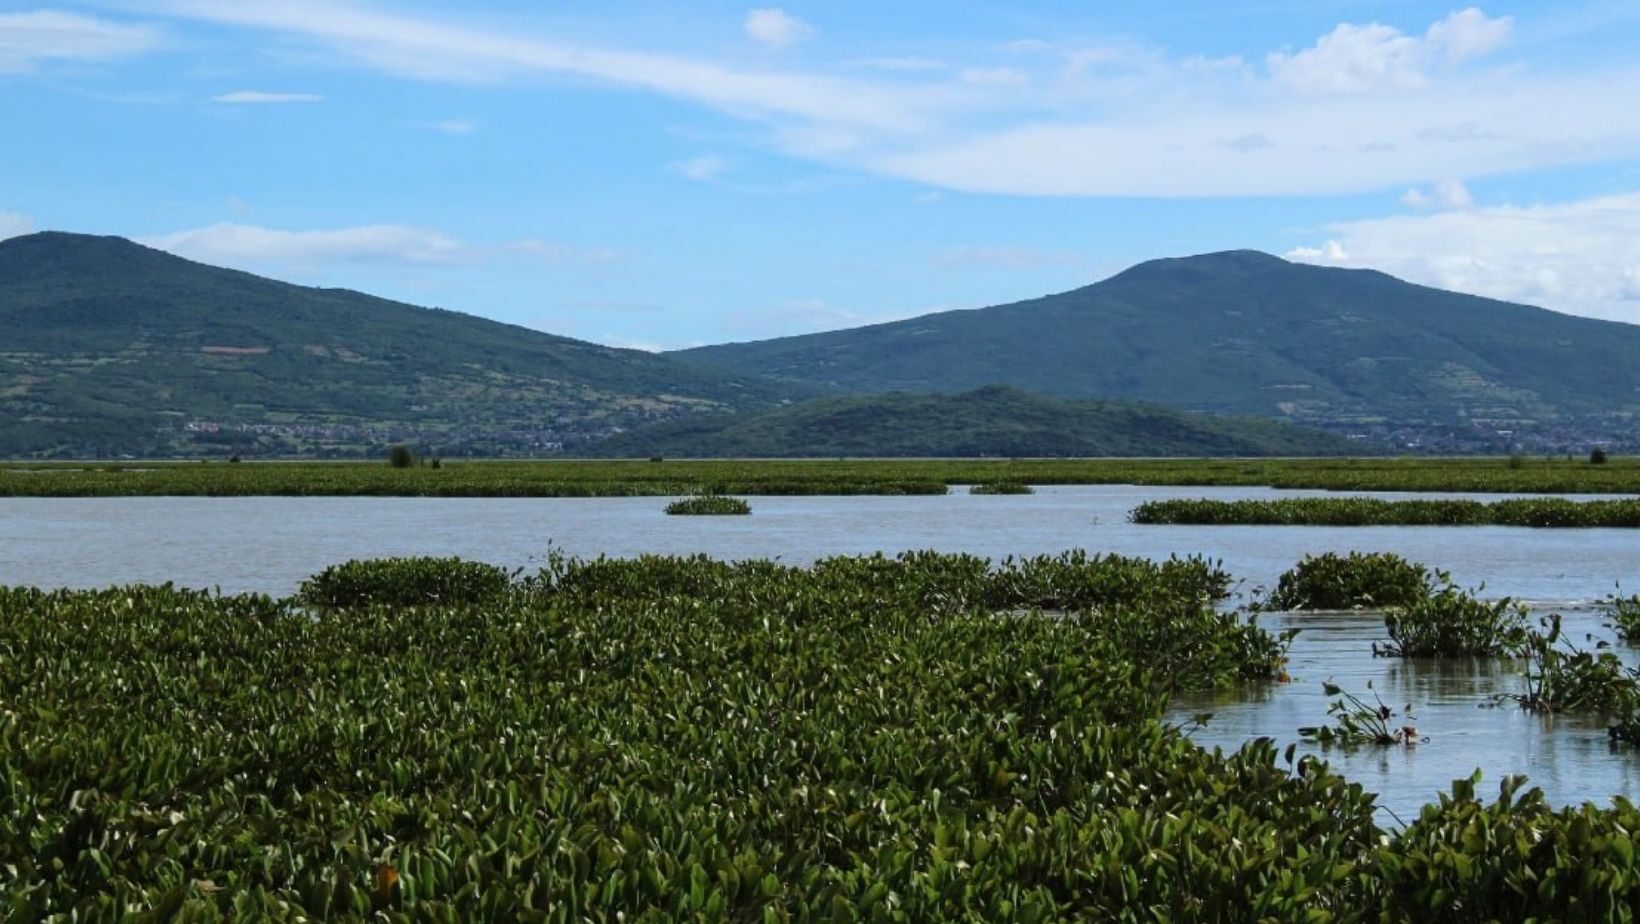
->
{"left": 0, "top": 553, "right": 1640, "bottom": 922}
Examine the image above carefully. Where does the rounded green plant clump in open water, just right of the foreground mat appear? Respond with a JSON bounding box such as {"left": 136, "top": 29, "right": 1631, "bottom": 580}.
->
{"left": 1269, "top": 551, "right": 1446, "bottom": 609}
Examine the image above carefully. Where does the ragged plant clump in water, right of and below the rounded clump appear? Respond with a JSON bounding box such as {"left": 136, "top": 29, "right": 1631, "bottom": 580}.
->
{"left": 1373, "top": 584, "right": 1527, "bottom": 658}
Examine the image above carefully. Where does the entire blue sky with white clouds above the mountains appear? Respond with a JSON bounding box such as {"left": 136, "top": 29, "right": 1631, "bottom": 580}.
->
{"left": 0, "top": 0, "right": 1640, "bottom": 350}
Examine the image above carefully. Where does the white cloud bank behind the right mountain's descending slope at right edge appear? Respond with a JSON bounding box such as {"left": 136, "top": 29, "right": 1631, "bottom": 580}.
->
{"left": 1287, "top": 192, "right": 1640, "bottom": 323}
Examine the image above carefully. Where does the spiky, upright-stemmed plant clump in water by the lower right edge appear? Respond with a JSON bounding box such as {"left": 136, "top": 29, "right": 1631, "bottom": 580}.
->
{"left": 1504, "top": 615, "right": 1640, "bottom": 716}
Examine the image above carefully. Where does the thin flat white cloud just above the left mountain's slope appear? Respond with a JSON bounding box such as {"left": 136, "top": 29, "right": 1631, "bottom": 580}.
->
{"left": 141, "top": 225, "right": 472, "bottom": 268}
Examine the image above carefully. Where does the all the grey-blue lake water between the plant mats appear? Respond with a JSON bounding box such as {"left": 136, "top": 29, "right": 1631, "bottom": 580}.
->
{"left": 0, "top": 486, "right": 1640, "bottom": 821}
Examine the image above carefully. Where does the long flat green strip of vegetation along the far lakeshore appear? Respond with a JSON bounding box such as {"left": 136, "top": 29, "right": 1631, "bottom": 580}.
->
{"left": 0, "top": 458, "right": 1640, "bottom": 497}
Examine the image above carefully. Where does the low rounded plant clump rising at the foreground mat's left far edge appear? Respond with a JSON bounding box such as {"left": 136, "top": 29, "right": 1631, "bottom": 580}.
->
{"left": 297, "top": 558, "right": 512, "bottom": 607}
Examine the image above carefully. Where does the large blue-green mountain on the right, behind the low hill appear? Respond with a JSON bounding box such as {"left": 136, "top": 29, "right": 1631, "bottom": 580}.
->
{"left": 676, "top": 251, "right": 1640, "bottom": 443}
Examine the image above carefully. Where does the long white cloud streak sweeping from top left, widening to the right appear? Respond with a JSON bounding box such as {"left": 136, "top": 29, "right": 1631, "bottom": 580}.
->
{"left": 134, "top": 0, "right": 1640, "bottom": 197}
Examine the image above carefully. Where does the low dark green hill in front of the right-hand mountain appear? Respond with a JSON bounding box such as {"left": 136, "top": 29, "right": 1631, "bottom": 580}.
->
{"left": 587, "top": 386, "right": 1373, "bottom": 458}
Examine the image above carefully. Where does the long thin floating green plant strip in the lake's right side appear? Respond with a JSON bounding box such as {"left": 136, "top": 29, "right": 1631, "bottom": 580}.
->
{"left": 1128, "top": 497, "right": 1640, "bottom": 528}
